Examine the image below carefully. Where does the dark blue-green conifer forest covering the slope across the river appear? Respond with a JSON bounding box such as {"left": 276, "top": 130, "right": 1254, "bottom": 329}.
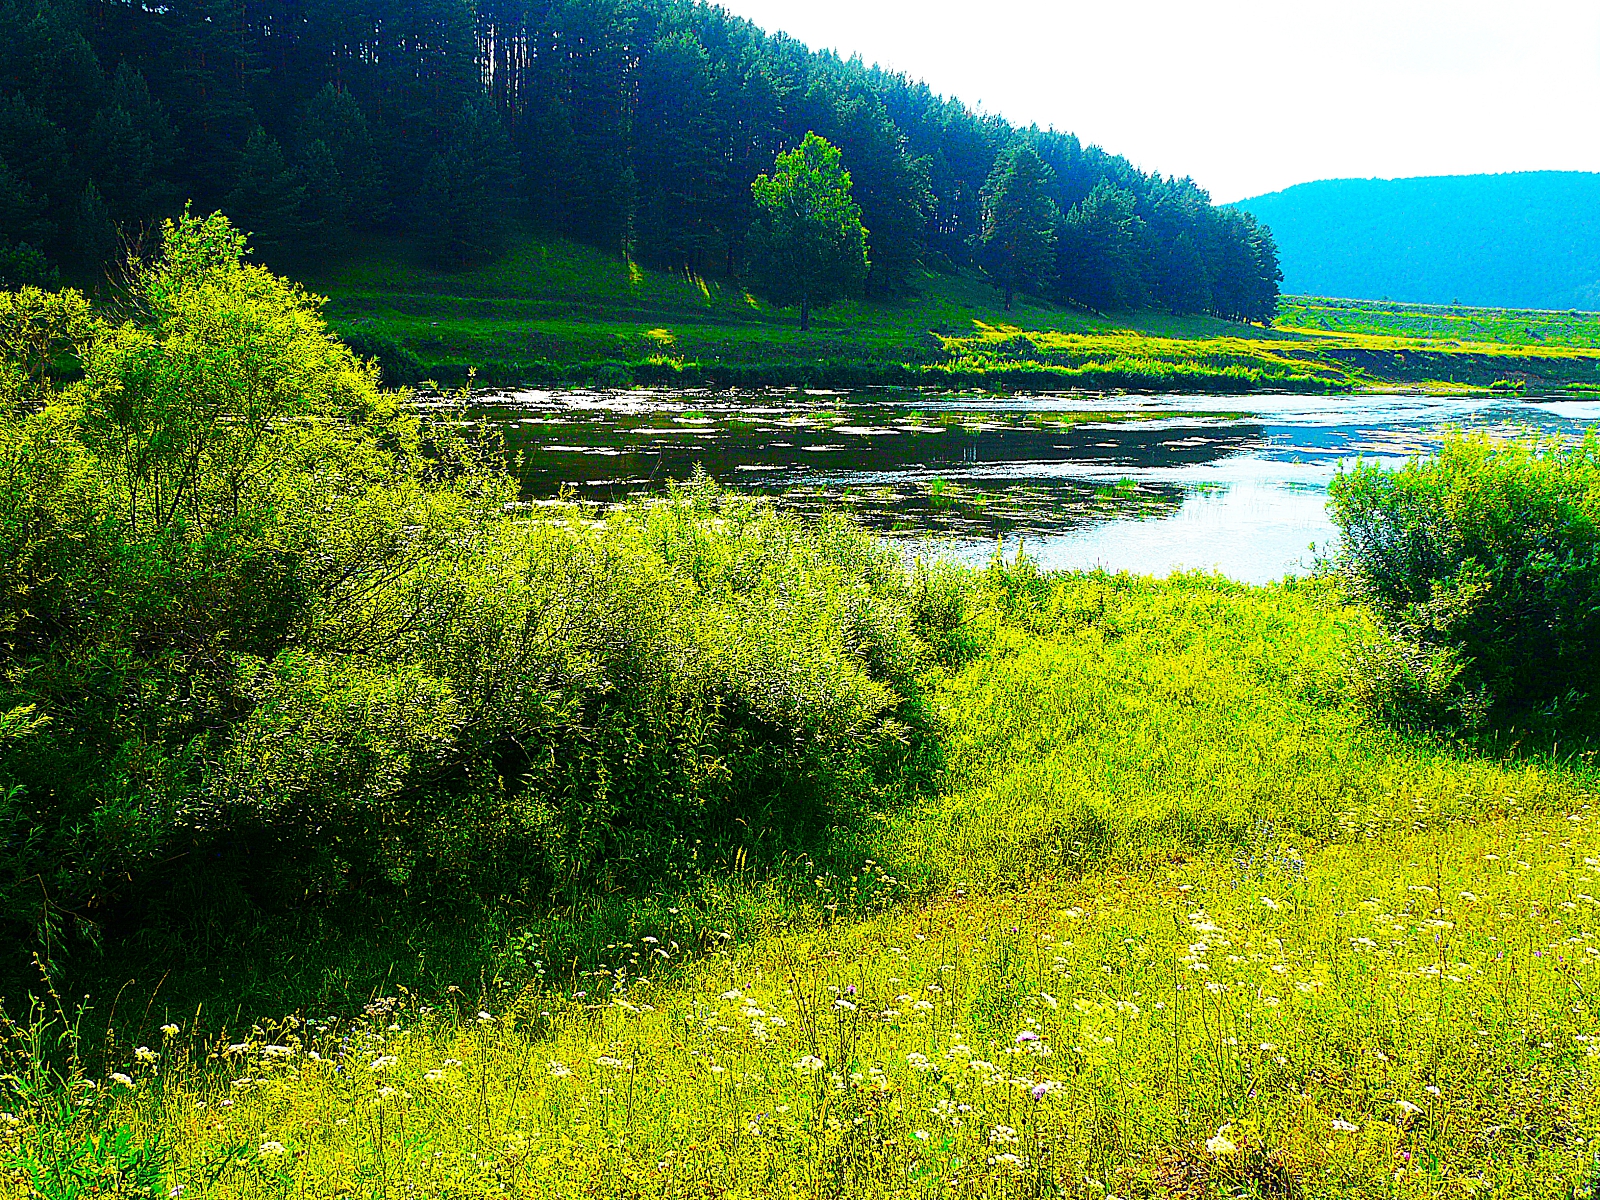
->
{"left": 0, "top": 0, "right": 1278, "bottom": 318}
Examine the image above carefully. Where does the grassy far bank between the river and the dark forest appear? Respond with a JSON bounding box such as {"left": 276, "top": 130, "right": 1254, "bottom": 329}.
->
{"left": 307, "top": 238, "right": 1600, "bottom": 400}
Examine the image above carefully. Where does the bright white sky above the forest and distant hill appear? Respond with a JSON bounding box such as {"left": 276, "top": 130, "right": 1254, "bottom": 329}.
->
{"left": 718, "top": 0, "right": 1600, "bottom": 203}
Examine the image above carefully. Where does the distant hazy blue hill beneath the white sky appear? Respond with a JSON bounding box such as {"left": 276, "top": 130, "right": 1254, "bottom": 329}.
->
{"left": 1235, "top": 171, "right": 1600, "bottom": 309}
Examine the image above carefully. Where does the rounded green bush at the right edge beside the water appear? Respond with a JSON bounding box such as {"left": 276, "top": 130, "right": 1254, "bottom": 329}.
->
{"left": 1330, "top": 435, "right": 1600, "bottom": 718}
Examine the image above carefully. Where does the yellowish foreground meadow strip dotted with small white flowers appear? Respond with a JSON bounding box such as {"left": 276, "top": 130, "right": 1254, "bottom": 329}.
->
{"left": 10, "top": 810, "right": 1600, "bottom": 1197}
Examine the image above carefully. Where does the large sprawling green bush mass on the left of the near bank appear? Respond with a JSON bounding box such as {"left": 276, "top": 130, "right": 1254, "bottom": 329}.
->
{"left": 0, "top": 218, "right": 962, "bottom": 971}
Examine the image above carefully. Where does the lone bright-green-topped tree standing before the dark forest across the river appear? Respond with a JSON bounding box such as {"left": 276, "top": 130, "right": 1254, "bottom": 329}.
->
{"left": 749, "top": 133, "right": 867, "bottom": 330}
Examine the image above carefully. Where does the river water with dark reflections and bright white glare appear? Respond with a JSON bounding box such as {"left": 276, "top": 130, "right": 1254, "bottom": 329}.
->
{"left": 474, "top": 392, "right": 1600, "bottom": 582}
